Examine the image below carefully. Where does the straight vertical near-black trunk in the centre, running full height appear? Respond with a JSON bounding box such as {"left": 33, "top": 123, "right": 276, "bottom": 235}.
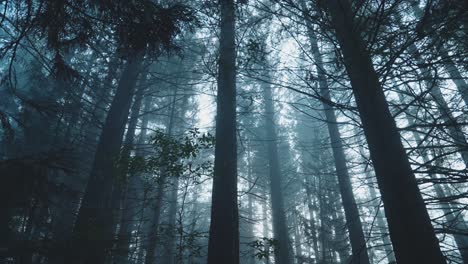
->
{"left": 208, "top": 0, "right": 239, "bottom": 264}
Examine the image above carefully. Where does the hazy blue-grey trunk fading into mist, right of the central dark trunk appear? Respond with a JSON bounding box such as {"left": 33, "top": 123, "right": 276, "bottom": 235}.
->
{"left": 263, "top": 80, "right": 294, "bottom": 264}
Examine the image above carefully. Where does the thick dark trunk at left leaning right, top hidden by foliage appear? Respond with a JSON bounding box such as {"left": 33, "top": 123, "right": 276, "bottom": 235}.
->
{"left": 69, "top": 52, "right": 144, "bottom": 264}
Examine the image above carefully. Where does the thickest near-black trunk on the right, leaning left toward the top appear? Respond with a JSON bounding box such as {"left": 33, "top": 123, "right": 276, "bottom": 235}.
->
{"left": 324, "top": 0, "right": 446, "bottom": 264}
